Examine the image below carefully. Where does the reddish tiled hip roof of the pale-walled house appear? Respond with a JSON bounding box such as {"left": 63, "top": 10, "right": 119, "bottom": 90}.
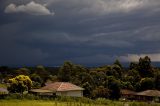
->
{"left": 41, "top": 82, "right": 84, "bottom": 91}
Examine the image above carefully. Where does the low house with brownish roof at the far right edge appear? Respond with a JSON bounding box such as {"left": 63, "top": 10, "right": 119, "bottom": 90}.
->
{"left": 135, "top": 90, "right": 160, "bottom": 102}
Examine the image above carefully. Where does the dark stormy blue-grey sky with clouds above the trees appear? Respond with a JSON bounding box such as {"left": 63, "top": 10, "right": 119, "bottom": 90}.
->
{"left": 0, "top": 0, "right": 160, "bottom": 66}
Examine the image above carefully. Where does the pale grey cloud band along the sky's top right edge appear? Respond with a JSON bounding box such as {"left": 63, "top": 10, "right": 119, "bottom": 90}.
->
{"left": 48, "top": 0, "right": 160, "bottom": 15}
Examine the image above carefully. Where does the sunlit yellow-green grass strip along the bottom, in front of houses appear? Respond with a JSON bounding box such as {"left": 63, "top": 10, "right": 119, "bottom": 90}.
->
{"left": 0, "top": 100, "right": 160, "bottom": 106}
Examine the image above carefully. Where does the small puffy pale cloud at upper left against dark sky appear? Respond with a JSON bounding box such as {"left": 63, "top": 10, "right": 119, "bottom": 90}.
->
{"left": 4, "top": 1, "right": 54, "bottom": 15}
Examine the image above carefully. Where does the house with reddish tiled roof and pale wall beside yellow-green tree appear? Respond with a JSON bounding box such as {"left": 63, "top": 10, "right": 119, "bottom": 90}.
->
{"left": 31, "top": 82, "right": 84, "bottom": 97}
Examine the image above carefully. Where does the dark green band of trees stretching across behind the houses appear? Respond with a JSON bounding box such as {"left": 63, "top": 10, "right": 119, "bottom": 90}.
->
{"left": 0, "top": 56, "right": 160, "bottom": 99}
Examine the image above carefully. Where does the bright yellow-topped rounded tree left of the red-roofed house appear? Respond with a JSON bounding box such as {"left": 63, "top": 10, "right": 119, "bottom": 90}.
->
{"left": 8, "top": 75, "right": 32, "bottom": 94}
